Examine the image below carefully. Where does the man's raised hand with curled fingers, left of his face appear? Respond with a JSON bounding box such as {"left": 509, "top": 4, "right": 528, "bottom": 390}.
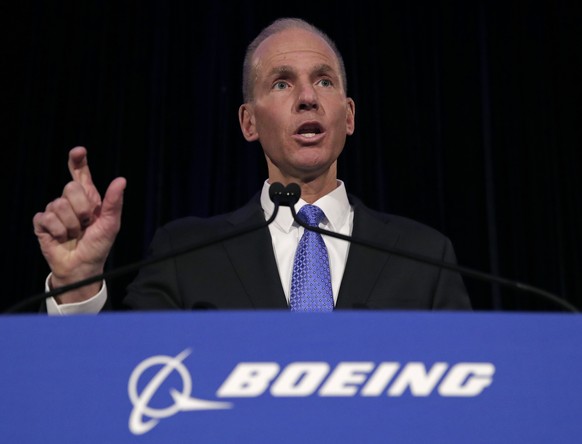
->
{"left": 33, "top": 147, "right": 126, "bottom": 303}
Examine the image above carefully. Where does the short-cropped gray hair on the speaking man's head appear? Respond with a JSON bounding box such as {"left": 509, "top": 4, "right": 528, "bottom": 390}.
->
{"left": 242, "top": 18, "right": 348, "bottom": 103}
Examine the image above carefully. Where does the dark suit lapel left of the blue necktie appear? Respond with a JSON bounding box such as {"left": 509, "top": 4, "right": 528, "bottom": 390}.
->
{"left": 224, "top": 196, "right": 287, "bottom": 309}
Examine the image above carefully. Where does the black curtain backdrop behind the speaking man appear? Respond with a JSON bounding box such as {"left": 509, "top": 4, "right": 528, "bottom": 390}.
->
{"left": 5, "top": 0, "right": 582, "bottom": 311}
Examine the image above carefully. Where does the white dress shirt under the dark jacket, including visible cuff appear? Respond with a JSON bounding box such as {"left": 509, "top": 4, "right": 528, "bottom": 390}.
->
{"left": 45, "top": 180, "right": 354, "bottom": 315}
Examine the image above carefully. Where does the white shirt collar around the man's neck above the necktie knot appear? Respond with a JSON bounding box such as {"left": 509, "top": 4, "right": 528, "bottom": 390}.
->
{"left": 261, "top": 180, "right": 351, "bottom": 233}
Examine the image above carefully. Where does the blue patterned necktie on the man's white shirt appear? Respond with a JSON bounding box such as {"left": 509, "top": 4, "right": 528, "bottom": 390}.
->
{"left": 290, "top": 205, "right": 333, "bottom": 312}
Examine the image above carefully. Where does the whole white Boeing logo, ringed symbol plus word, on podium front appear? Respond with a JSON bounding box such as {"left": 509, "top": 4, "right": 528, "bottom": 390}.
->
{"left": 128, "top": 356, "right": 495, "bottom": 435}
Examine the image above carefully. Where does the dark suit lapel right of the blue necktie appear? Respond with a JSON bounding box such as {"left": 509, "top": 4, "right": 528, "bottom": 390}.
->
{"left": 336, "top": 197, "right": 398, "bottom": 309}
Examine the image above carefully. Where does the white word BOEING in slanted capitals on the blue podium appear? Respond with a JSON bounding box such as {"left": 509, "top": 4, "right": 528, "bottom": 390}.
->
{"left": 216, "top": 362, "right": 495, "bottom": 398}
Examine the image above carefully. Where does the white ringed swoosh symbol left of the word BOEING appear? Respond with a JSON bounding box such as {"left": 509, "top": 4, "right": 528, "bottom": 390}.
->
{"left": 127, "top": 349, "right": 232, "bottom": 435}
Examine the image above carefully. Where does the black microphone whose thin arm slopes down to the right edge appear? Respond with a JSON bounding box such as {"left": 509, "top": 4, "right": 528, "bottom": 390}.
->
{"left": 280, "top": 183, "right": 579, "bottom": 313}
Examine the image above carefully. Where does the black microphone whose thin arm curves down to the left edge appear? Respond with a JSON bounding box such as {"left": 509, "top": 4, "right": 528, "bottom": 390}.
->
{"left": 3, "top": 186, "right": 290, "bottom": 314}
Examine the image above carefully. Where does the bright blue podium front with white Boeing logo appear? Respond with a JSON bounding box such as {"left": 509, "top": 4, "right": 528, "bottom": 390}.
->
{"left": 0, "top": 311, "right": 582, "bottom": 444}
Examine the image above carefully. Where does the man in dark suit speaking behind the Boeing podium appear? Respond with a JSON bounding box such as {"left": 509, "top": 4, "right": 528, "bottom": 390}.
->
{"left": 33, "top": 19, "right": 470, "bottom": 314}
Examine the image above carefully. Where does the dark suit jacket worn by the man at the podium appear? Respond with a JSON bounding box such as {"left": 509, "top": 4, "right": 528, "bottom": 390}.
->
{"left": 124, "top": 195, "right": 470, "bottom": 310}
